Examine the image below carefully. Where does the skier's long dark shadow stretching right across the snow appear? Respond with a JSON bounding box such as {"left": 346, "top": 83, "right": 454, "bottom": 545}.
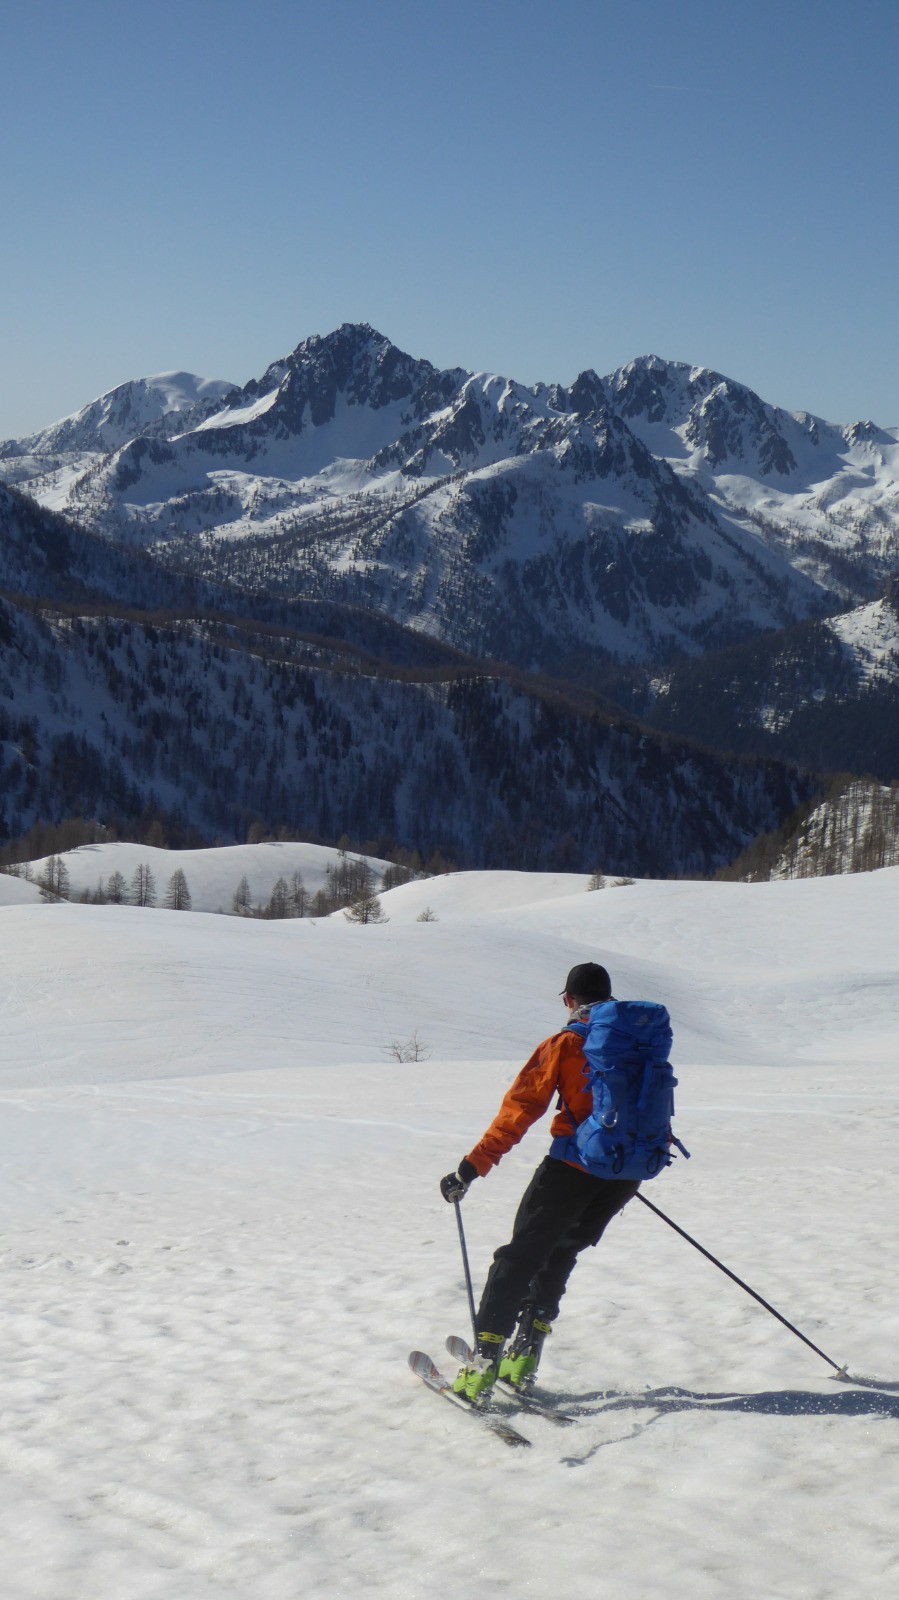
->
{"left": 558, "top": 1378, "right": 899, "bottom": 1466}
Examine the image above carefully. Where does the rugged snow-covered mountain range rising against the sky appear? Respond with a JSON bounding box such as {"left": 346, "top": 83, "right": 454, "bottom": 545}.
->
{"left": 8, "top": 325, "right": 899, "bottom": 672}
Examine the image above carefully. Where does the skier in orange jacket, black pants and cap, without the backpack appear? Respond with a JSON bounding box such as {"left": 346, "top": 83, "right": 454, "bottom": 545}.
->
{"left": 440, "top": 962, "right": 640, "bottom": 1403}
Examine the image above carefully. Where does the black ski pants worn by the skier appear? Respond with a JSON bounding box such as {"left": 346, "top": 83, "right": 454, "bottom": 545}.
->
{"left": 477, "top": 1155, "right": 640, "bottom": 1338}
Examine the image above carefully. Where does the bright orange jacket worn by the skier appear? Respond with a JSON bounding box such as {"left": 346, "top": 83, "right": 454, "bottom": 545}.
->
{"left": 467, "top": 1029, "right": 593, "bottom": 1178}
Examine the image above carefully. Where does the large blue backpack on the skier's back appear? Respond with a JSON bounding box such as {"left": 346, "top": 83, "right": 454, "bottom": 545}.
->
{"left": 550, "top": 1000, "right": 689, "bottom": 1182}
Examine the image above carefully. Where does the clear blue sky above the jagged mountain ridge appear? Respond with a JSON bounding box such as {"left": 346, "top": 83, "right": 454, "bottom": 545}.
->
{"left": 0, "top": 0, "right": 899, "bottom": 437}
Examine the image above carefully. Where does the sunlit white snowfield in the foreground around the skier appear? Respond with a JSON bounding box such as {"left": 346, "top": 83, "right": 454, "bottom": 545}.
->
{"left": 0, "top": 870, "right": 899, "bottom": 1600}
